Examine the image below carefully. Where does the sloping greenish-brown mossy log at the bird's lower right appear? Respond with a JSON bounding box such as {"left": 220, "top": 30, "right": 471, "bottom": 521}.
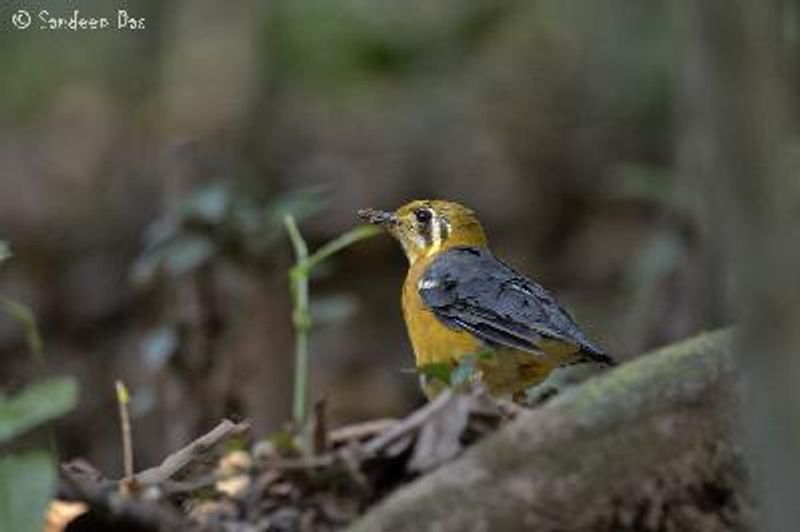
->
{"left": 351, "top": 331, "right": 753, "bottom": 532}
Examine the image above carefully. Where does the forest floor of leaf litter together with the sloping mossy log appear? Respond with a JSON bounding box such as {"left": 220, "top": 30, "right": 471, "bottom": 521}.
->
{"left": 48, "top": 331, "right": 757, "bottom": 532}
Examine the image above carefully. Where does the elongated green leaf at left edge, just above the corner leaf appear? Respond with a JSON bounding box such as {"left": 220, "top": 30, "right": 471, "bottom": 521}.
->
{"left": 0, "top": 377, "right": 78, "bottom": 443}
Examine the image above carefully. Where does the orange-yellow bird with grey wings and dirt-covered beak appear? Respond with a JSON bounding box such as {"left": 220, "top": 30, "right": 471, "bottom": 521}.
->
{"left": 358, "top": 200, "right": 614, "bottom": 402}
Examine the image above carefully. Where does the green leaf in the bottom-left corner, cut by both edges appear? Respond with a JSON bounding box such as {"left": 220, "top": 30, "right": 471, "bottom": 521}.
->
{"left": 0, "top": 451, "right": 56, "bottom": 532}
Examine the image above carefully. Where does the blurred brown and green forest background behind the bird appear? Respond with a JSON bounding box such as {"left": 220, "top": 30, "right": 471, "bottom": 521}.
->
{"left": 0, "top": 0, "right": 736, "bottom": 473}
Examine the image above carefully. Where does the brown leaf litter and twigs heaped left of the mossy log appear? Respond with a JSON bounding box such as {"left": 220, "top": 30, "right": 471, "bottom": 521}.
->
{"left": 57, "top": 390, "right": 521, "bottom": 532}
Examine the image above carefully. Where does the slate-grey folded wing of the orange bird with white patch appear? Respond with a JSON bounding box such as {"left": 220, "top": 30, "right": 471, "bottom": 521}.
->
{"left": 418, "top": 247, "right": 612, "bottom": 364}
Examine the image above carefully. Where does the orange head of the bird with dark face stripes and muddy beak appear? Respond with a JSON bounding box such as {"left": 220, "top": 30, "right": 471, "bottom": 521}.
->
{"left": 358, "top": 200, "right": 486, "bottom": 264}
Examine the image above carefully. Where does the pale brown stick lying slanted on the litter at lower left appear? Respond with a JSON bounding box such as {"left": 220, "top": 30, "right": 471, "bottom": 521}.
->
{"left": 133, "top": 419, "right": 250, "bottom": 486}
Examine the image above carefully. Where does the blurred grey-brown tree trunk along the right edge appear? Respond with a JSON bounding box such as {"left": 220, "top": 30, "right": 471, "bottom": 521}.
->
{"left": 682, "top": 0, "right": 800, "bottom": 532}
